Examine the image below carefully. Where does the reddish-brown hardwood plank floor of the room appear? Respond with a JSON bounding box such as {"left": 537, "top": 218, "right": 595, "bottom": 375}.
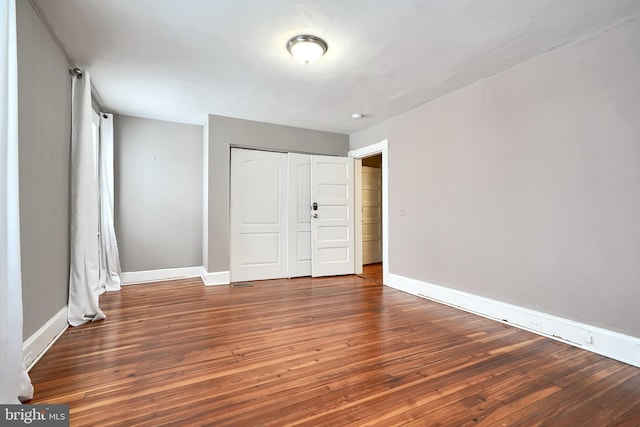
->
{"left": 26, "top": 276, "right": 640, "bottom": 427}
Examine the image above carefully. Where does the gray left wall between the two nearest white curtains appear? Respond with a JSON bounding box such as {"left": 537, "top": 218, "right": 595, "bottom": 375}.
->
{"left": 16, "top": 0, "right": 71, "bottom": 339}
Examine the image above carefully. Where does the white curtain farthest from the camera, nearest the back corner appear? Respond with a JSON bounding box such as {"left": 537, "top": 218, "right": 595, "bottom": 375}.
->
{"left": 99, "top": 113, "right": 120, "bottom": 291}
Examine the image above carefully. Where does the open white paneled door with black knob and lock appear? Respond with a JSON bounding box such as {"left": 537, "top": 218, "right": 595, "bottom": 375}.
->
{"left": 311, "top": 156, "right": 355, "bottom": 277}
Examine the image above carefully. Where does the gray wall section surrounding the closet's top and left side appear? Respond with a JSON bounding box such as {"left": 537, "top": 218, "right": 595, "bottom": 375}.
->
{"left": 204, "top": 115, "right": 349, "bottom": 273}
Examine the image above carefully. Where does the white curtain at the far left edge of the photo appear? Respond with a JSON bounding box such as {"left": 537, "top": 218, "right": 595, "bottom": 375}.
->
{"left": 0, "top": 0, "right": 33, "bottom": 404}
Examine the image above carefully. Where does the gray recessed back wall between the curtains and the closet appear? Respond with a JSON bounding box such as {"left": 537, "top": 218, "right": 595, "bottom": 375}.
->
{"left": 114, "top": 116, "right": 203, "bottom": 272}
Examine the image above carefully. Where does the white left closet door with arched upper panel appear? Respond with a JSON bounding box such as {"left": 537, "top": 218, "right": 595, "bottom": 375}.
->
{"left": 230, "top": 148, "right": 287, "bottom": 282}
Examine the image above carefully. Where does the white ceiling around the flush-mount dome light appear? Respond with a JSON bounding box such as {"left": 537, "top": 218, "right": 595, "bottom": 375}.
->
{"left": 32, "top": 0, "right": 640, "bottom": 133}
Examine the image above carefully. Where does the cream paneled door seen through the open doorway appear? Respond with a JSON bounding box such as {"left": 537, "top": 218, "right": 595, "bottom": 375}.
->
{"left": 362, "top": 166, "right": 382, "bottom": 264}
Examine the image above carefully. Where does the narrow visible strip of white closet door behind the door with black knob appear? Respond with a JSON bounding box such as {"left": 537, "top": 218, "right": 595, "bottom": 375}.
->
{"left": 288, "top": 153, "right": 311, "bottom": 277}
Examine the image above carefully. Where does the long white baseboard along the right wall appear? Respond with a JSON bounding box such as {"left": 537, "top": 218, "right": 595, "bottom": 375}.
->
{"left": 385, "top": 273, "right": 640, "bottom": 367}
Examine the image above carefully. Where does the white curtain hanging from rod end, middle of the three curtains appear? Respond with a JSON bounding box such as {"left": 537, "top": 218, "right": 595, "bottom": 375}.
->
{"left": 68, "top": 71, "right": 105, "bottom": 326}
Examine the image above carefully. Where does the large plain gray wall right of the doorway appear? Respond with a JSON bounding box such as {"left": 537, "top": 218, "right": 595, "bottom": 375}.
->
{"left": 389, "top": 18, "right": 640, "bottom": 337}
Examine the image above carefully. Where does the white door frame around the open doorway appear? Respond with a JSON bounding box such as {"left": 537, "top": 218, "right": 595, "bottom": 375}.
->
{"left": 349, "top": 139, "right": 389, "bottom": 284}
